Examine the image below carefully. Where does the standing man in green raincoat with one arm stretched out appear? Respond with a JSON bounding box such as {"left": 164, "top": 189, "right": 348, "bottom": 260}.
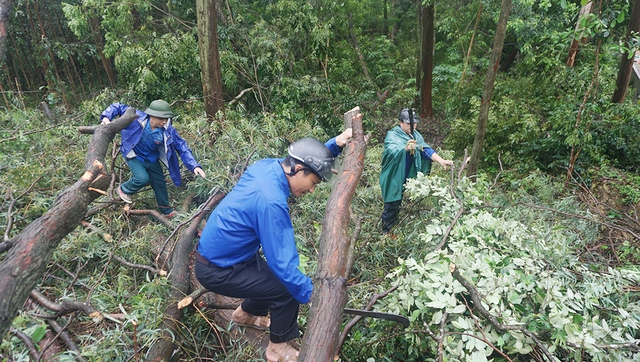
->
{"left": 380, "top": 108, "right": 453, "bottom": 233}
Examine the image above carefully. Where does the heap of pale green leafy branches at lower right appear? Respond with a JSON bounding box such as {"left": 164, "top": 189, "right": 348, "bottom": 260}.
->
{"left": 372, "top": 177, "right": 640, "bottom": 361}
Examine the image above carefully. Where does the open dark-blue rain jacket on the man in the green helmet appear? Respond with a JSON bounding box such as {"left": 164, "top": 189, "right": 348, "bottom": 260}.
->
{"left": 100, "top": 103, "right": 202, "bottom": 186}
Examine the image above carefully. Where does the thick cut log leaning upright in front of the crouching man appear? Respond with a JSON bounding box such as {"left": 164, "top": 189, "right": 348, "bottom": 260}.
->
{"left": 298, "top": 109, "right": 367, "bottom": 361}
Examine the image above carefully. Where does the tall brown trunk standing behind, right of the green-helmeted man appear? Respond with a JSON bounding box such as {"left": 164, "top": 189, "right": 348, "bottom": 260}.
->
{"left": 196, "top": 0, "right": 224, "bottom": 120}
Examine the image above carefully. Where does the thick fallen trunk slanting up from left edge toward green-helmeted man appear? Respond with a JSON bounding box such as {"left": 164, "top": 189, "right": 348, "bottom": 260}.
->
{"left": 0, "top": 109, "right": 136, "bottom": 338}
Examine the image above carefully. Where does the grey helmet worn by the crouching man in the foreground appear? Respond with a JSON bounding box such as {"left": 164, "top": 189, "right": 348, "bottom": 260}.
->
{"left": 289, "top": 138, "right": 335, "bottom": 181}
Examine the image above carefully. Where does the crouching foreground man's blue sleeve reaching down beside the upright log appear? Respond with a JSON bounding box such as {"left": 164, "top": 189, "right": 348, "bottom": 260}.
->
{"left": 256, "top": 200, "right": 313, "bottom": 304}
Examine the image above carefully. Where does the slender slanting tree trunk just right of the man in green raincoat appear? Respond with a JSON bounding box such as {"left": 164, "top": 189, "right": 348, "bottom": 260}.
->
{"left": 467, "top": 0, "right": 511, "bottom": 177}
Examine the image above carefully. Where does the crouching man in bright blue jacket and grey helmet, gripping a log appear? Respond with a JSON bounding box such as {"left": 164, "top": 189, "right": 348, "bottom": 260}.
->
{"left": 195, "top": 128, "right": 351, "bottom": 361}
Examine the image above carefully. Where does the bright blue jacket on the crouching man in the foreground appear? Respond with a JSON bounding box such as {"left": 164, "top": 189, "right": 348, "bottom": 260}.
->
{"left": 198, "top": 138, "right": 342, "bottom": 303}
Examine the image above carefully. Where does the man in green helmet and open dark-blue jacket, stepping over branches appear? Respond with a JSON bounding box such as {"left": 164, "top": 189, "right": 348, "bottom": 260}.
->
{"left": 100, "top": 99, "right": 205, "bottom": 218}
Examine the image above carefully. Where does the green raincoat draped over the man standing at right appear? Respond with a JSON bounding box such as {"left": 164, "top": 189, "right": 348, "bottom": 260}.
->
{"left": 380, "top": 126, "right": 431, "bottom": 202}
